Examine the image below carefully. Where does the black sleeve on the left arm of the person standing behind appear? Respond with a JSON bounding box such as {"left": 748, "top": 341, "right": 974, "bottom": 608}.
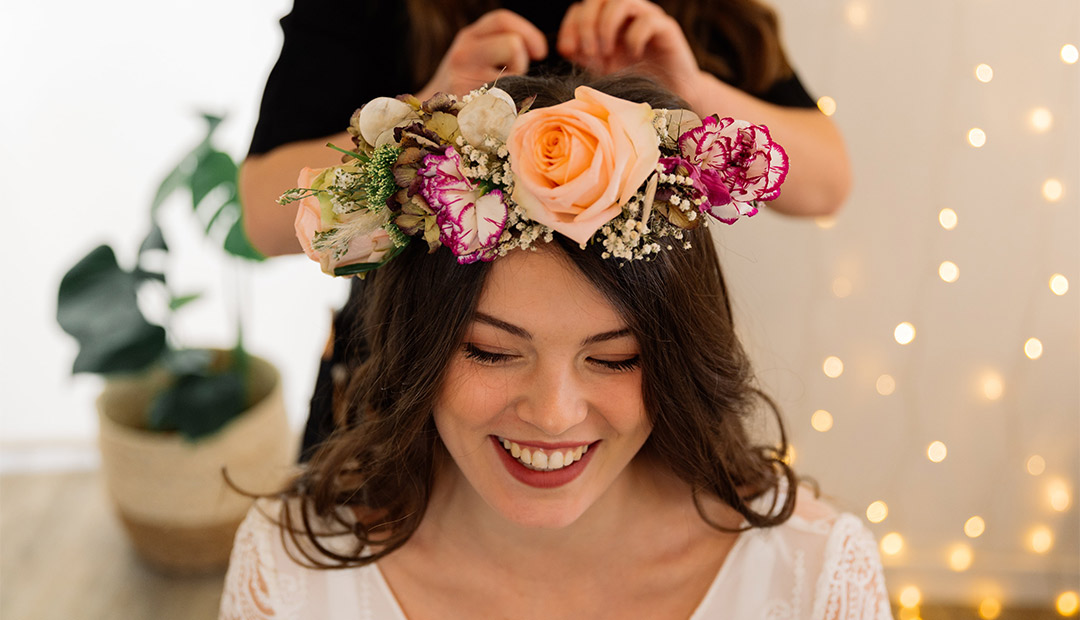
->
{"left": 248, "top": 0, "right": 415, "bottom": 154}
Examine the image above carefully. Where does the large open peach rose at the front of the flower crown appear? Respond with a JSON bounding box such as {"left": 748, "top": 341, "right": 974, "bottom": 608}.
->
{"left": 507, "top": 86, "right": 660, "bottom": 243}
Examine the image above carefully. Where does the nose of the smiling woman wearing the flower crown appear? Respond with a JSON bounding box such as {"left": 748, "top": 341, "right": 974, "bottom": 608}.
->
{"left": 517, "top": 358, "right": 589, "bottom": 436}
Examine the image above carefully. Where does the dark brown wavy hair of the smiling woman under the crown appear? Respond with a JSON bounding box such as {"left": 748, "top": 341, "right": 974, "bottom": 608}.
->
{"left": 274, "top": 76, "right": 796, "bottom": 567}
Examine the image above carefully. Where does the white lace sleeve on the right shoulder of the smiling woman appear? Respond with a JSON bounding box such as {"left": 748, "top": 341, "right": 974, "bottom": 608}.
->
{"left": 812, "top": 514, "right": 892, "bottom": 620}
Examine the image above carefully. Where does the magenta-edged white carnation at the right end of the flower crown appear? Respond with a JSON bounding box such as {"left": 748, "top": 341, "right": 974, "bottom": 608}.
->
{"left": 678, "top": 117, "right": 787, "bottom": 206}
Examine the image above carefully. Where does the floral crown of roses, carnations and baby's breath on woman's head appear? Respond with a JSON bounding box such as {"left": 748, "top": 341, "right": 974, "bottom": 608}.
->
{"left": 278, "top": 86, "right": 787, "bottom": 275}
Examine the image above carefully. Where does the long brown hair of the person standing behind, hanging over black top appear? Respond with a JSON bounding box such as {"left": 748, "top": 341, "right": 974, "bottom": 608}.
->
{"left": 406, "top": 0, "right": 792, "bottom": 94}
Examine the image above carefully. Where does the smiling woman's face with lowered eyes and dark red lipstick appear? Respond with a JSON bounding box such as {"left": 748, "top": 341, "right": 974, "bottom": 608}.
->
{"left": 435, "top": 250, "right": 650, "bottom": 527}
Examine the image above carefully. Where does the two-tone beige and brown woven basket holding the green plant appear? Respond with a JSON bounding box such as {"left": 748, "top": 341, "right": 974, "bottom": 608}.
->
{"left": 97, "top": 356, "right": 295, "bottom": 575}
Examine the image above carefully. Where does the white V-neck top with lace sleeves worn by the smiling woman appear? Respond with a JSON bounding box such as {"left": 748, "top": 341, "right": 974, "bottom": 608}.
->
{"left": 219, "top": 491, "right": 892, "bottom": 620}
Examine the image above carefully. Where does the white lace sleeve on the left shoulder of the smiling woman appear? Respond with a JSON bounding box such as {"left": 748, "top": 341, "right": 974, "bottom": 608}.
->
{"left": 218, "top": 507, "right": 305, "bottom": 620}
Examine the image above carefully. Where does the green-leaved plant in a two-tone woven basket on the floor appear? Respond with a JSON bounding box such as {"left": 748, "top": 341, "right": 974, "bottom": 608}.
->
{"left": 57, "top": 116, "right": 295, "bottom": 572}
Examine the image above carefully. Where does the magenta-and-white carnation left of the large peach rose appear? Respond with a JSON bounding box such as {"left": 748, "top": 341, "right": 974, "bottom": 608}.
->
{"left": 419, "top": 147, "right": 509, "bottom": 265}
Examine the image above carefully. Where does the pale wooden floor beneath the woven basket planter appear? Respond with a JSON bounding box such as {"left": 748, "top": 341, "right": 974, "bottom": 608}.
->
{"left": 0, "top": 471, "right": 1061, "bottom": 620}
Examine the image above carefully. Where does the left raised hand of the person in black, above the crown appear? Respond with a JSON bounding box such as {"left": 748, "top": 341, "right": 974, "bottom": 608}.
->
{"left": 418, "top": 9, "right": 548, "bottom": 99}
